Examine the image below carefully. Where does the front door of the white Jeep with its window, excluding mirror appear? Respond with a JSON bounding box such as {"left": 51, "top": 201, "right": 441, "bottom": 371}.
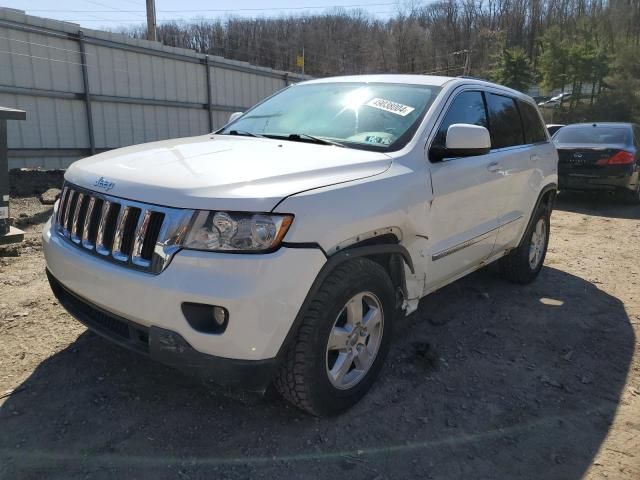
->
{"left": 425, "top": 90, "right": 500, "bottom": 290}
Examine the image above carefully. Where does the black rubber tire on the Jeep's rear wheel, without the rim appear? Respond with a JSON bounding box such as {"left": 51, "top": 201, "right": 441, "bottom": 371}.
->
{"left": 498, "top": 205, "right": 551, "bottom": 285}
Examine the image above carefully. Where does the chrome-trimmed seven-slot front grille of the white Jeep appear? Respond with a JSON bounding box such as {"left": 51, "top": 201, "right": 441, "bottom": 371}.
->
{"left": 54, "top": 184, "right": 193, "bottom": 273}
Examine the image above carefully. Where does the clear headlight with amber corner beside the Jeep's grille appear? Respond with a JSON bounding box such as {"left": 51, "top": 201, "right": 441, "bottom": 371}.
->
{"left": 183, "top": 210, "right": 293, "bottom": 252}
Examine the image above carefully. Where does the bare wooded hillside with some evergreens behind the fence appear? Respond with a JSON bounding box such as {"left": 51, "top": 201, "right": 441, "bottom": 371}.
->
{"left": 120, "top": 0, "right": 640, "bottom": 121}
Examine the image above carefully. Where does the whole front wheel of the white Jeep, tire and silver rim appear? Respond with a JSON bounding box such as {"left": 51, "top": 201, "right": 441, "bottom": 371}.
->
{"left": 275, "top": 258, "right": 395, "bottom": 416}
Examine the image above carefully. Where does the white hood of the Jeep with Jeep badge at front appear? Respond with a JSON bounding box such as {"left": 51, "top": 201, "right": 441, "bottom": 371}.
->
{"left": 65, "top": 134, "right": 391, "bottom": 212}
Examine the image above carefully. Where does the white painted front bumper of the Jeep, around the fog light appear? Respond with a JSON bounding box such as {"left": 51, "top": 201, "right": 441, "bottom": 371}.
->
{"left": 43, "top": 216, "right": 326, "bottom": 361}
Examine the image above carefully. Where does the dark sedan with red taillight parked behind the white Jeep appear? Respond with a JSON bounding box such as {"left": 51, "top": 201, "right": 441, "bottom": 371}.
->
{"left": 553, "top": 123, "right": 640, "bottom": 204}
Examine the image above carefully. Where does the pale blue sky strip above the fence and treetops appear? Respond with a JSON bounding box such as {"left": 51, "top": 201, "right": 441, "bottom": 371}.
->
{"left": 0, "top": 0, "right": 399, "bottom": 29}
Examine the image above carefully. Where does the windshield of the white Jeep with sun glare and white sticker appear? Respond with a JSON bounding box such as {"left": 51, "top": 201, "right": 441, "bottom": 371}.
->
{"left": 218, "top": 83, "right": 440, "bottom": 151}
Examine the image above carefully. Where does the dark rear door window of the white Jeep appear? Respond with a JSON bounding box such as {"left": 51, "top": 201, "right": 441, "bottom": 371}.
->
{"left": 487, "top": 93, "right": 524, "bottom": 148}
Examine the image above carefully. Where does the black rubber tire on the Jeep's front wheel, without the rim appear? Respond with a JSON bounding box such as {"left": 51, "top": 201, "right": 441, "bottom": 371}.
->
{"left": 274, "top": 258, "right": 395, "bottom": 416}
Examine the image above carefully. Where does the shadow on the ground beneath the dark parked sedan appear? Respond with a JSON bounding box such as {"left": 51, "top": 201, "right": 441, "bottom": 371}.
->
{"left": 554, "top": 192, "right": 640, "bottom": 220}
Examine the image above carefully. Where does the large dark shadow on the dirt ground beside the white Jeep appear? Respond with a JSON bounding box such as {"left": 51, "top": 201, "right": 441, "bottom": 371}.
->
{"left": 0, "top": 268, "right": 635, "bottom": 480}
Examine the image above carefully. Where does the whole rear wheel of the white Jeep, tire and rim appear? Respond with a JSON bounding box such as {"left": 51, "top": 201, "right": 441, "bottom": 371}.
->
{"left": 499, "top": 207, "right": 551, "bottom": 284}
